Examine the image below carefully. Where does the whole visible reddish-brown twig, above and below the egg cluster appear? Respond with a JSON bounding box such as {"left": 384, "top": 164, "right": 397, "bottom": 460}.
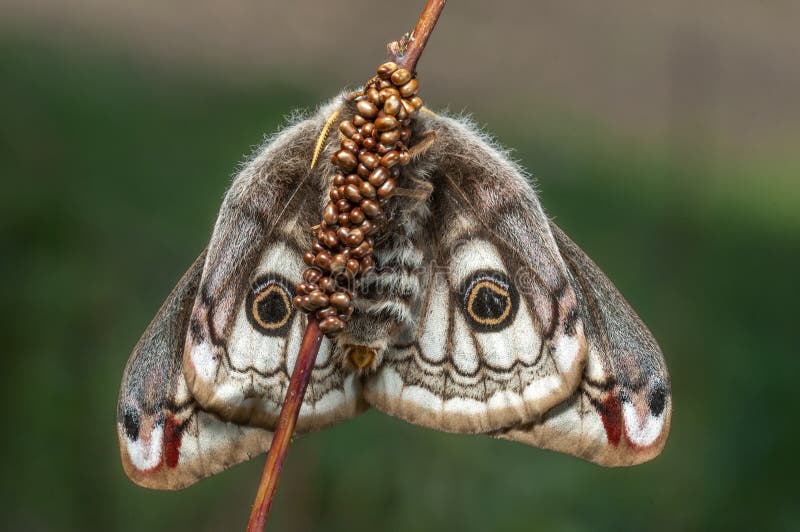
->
{"left": 247, "top": 0, "right": 445, "bottom": 532}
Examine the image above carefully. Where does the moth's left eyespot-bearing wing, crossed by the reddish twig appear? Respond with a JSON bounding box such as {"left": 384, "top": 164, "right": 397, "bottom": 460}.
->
{"left": 183, "top": 97, "right": 365, "bottom": 431}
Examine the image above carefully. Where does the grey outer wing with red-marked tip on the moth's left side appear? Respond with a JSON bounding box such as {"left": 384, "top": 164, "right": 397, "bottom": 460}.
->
{"left": 117, "top": 252, "right": 272, "bottom": 489}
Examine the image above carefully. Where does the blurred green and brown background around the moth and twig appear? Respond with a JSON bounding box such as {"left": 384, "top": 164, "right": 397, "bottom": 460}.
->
{"left": 0, "top": 0, "right": 800, "bottom": 531}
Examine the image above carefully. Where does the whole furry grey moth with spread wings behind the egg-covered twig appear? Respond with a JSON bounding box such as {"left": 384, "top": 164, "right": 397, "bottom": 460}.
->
{"left": 117, "top": 94, "right": 672, "bottom": 489}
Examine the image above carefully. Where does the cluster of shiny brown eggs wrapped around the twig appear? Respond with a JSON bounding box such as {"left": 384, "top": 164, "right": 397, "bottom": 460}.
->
{"left": 293, "top": 62, "right": 422, "bottom": 336}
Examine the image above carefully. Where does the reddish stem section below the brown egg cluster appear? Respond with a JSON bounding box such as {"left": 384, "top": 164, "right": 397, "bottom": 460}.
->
{"left": 247, "top": 313, "right": 322, "bottom": 532}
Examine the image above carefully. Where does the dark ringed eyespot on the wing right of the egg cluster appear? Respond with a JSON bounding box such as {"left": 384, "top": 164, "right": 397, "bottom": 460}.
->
{"left": 460, "top": 270, "right": 519, "bottom": 332}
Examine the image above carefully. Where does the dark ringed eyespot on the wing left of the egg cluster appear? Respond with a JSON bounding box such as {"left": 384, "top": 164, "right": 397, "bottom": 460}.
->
{"left": 245, "top": 274, "right": 294, "bottom": 336}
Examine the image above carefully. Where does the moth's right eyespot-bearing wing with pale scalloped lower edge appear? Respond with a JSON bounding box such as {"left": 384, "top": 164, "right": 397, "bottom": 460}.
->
{"left": 365, "top": 117, "right": 586, "bottom": 433}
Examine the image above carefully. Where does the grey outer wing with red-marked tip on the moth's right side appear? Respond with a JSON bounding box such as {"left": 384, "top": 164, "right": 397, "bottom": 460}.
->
{"left": 498, "top": 224, "right": 672, "bottom": 466}
